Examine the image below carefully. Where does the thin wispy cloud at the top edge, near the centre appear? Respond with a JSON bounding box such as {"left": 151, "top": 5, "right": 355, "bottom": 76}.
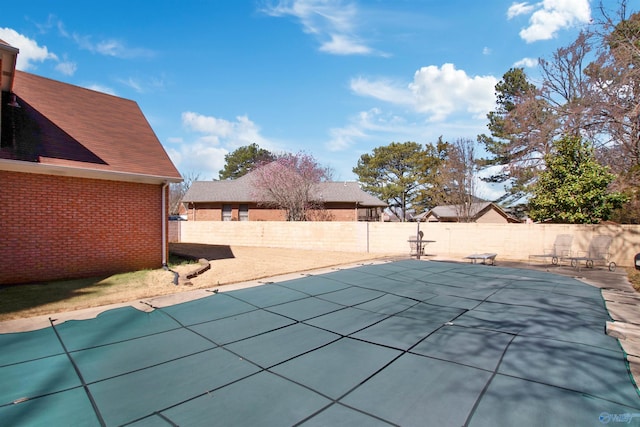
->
{"left": 262, "top": 0, "right": 380, "bottom": 55}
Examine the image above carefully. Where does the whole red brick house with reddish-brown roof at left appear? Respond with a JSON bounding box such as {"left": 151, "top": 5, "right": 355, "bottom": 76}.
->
{"left": 0, "top": 41, "right": 182, "bottom": 284}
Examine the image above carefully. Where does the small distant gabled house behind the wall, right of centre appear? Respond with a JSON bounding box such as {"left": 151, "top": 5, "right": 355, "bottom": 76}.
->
{"left": 414, "top": 202, "right": 520, "bottom": 223}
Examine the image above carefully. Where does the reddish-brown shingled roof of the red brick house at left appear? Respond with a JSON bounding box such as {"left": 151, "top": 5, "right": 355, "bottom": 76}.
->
{"left": 0, "top": 71, "right": 182, "bottom": 182}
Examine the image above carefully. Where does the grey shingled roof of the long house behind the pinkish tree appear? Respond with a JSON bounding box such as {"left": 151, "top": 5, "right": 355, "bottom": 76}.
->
{"left": 182, "top": 173, "right": 387, "bottom": 207}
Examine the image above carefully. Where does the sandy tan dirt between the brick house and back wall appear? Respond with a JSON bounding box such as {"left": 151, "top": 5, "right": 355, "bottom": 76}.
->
{"left": 169, "top": 243, "right": 398, "bottom": 289}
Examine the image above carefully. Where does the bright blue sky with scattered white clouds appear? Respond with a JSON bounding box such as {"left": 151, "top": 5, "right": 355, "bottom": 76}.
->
{"left": 0, "top": 0, "right": 640, "bottom": 199}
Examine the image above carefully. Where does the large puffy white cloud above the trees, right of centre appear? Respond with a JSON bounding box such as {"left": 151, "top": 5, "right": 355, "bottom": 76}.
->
{"left": 325, "top": 64, "right": 498, "bottom": 151}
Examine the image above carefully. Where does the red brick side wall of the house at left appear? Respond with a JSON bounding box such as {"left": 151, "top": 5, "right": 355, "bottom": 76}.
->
{"left": 0, "top": 171, "right": 162, "bottom": 284}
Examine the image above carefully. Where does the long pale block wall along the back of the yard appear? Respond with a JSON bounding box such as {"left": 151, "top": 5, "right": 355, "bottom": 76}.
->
{"left": 180, "top": 221, "right": 640, "bottom": 266}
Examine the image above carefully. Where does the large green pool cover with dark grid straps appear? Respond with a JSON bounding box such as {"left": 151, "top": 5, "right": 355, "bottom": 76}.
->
{"left": 0, "top": 260, "right": 640, "bottom": 426}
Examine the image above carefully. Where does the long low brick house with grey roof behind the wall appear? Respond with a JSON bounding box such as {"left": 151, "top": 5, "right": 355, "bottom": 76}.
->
{"left": 182, "top": 173, "right": 387, "bottom": 221}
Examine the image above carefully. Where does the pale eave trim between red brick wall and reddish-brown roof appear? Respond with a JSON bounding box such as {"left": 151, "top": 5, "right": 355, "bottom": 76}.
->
{"left": 0, "top": 159, "right": 183, "bottom": 184}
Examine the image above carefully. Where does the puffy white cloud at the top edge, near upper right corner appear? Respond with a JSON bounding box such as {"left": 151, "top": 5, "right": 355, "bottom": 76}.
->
{"left": 507, "top": 0, "right": 591, "bottom": 43}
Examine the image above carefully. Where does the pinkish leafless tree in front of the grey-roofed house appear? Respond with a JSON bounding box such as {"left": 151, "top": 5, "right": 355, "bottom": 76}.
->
{"left": 252, "top": 153, "right": 331, "bottom": 221}
